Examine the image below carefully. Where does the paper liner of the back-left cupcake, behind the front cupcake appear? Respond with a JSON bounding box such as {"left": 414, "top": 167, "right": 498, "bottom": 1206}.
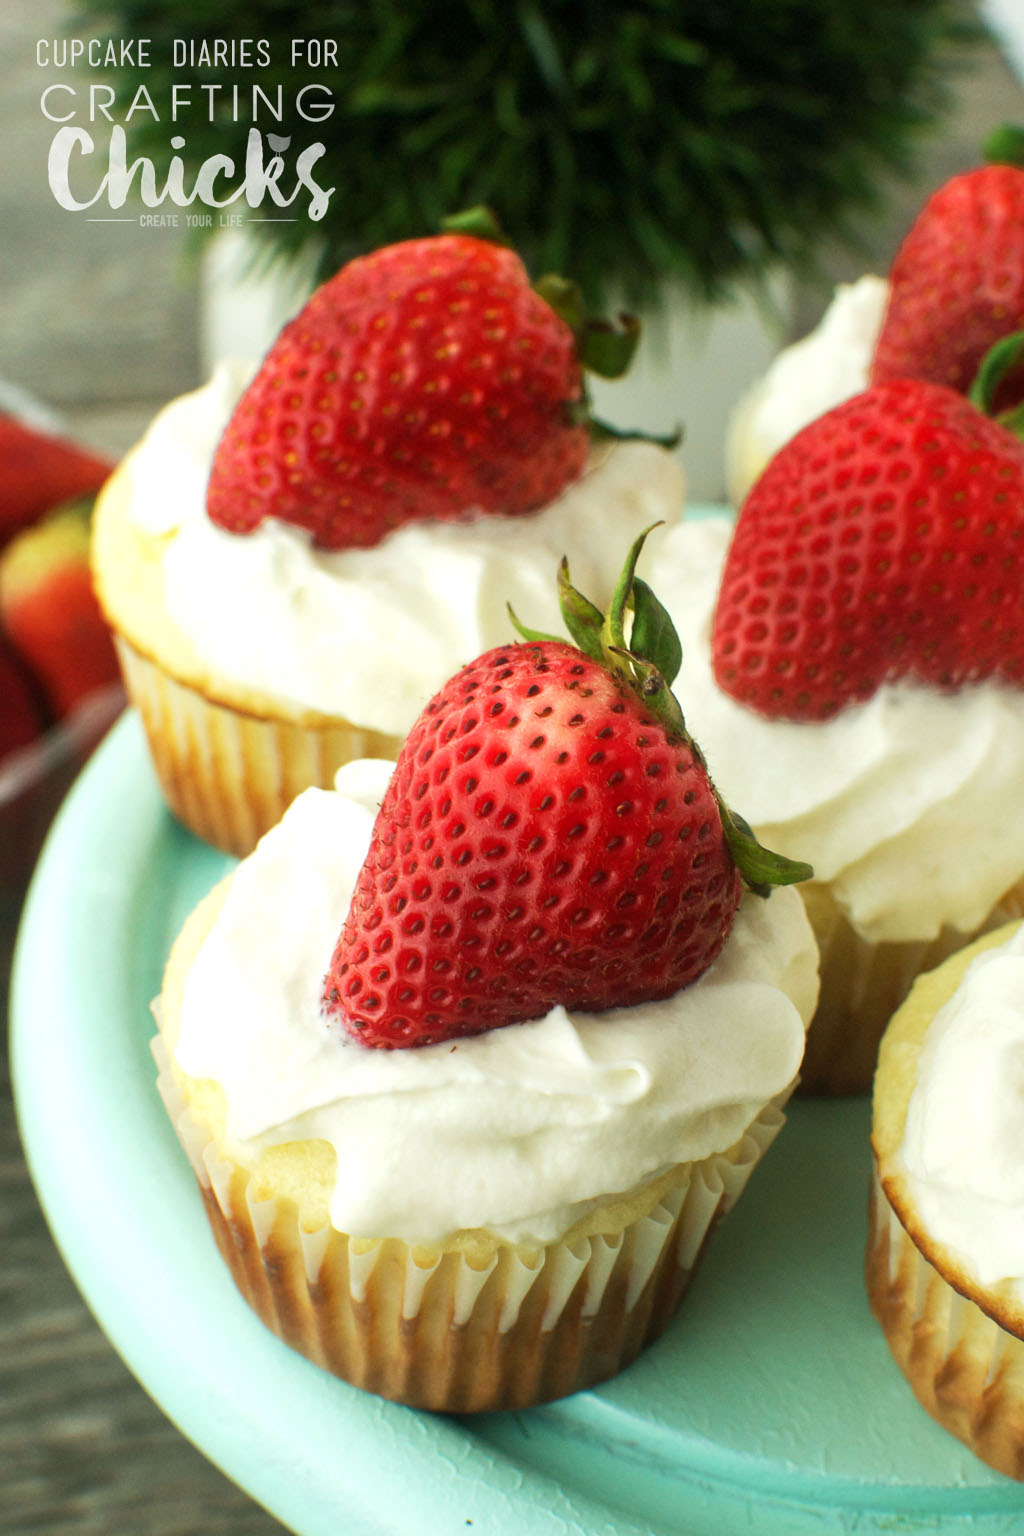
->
{"left": 115, "top": 634, "right": 401, "bottom": 856}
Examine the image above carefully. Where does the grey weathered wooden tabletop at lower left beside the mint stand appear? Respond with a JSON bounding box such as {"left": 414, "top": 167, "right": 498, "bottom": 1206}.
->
{"left": 0, "top": 872, "right": 290, "bottom": 1536}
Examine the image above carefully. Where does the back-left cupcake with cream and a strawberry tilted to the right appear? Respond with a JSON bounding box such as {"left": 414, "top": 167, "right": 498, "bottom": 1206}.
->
{"left": 94, "top": 219, "right": 682, "bottom": 854}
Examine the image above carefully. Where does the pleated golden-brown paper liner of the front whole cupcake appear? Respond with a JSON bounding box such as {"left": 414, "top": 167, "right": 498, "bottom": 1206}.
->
{"left": 154, "top": 1037, "right": 789, "bottom": 1413}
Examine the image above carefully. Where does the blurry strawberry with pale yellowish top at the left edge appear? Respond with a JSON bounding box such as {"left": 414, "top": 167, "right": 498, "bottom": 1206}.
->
{"left": 0, "top": 507, "right": 118, "bottom": 719}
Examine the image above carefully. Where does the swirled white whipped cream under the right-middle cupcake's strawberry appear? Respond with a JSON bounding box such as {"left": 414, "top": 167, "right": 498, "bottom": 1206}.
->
{"left": 649, "top": 518, "right": 1024, "bottom": 942}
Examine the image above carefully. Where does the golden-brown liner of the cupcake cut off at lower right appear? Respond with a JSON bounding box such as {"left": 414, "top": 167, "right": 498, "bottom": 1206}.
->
{"left": 864, "top": 1174, "right": 1024, "bottom": 1479}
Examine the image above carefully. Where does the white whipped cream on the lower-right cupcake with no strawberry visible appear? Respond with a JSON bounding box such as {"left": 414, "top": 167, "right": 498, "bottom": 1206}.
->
{"left": 900, "top": 928, "right": 1024, "bottom": 1301}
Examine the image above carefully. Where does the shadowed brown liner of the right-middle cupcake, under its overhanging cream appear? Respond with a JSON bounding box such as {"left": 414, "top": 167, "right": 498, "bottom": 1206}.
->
{"left": 800, "top": 880, "right": 1024, "bottom": 1095}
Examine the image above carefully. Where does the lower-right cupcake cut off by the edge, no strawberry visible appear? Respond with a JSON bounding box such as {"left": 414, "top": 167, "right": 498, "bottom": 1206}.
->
{"left": 866, "top": 923, "right": 1024, "bottom": 1478}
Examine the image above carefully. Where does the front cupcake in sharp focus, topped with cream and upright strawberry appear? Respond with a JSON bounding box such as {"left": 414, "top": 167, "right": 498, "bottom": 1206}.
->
{"left": 155, "top": 534, "right": 817, "bottom": 1412}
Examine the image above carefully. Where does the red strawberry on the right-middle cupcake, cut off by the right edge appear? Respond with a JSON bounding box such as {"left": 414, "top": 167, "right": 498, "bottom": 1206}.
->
{"left": 712, "top": 377, "right": 1024, "bottom": 720}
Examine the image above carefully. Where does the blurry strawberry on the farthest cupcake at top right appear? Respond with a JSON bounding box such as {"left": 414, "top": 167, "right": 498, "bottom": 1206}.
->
{"left": 870, "top": 164, "right": 1024, "bottom": 410}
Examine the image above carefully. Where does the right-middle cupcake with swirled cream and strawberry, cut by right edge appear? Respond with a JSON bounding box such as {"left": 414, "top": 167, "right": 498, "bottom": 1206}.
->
{"left": 656, "top": 370, "right": 1024, "bottom": 1092}
